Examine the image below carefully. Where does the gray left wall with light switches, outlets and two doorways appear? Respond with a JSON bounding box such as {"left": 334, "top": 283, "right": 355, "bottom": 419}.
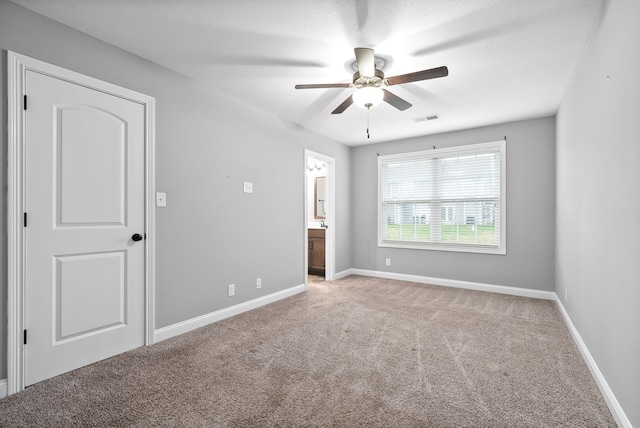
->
{"left": 0, "top": 0, "right": 351, "bottom": 379}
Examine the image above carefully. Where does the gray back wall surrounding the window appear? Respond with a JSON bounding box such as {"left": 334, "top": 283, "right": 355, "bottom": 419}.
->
{"left": 351, "top": 118, "right": 555, "bottom": 291}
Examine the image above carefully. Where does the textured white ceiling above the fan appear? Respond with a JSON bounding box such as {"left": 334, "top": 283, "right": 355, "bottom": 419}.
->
{"left": 12, "top": 0, "right": 602, "bottom": 146}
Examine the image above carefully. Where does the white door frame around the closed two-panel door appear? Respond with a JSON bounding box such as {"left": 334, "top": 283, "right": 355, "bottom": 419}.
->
{"left": 7, "top": 51, "right": 155, "bottom": 395}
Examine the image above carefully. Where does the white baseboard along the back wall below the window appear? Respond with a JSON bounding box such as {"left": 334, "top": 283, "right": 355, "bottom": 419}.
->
{"left": 336, "top": 269, "right": 556, "bottom": 300}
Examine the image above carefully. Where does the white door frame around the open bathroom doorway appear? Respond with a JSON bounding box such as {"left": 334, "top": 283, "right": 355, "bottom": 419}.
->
{"left": 304, "top": 149, "right": 336, "bottom": 289}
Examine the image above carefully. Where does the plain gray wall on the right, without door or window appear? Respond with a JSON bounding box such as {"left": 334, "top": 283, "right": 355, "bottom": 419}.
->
{"left": 556, "top": 0, "right": 640, "bottom": 427}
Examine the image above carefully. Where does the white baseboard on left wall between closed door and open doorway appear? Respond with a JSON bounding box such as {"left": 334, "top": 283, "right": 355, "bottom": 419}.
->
{"left": 154, "top": 284, "right": 307, "bottom": 343}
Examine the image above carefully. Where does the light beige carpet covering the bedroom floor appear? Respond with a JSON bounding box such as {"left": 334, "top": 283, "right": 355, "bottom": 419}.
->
{"left": 0, "top": 276, "right": 615, "bottom": 427}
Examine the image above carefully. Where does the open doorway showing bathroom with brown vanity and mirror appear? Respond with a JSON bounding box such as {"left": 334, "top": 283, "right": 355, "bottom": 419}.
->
{"left": 304, "top": 150, "right": 335, "bottom": 285}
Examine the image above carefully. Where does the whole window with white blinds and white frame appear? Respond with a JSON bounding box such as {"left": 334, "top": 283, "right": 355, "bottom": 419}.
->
{"left": 378, "top": 141, "right": 506, "bottom": 254}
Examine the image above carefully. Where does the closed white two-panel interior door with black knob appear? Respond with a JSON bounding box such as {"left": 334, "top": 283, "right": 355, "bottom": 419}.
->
{"left": 23, "top": 70, "right": 145, "bottom": 386}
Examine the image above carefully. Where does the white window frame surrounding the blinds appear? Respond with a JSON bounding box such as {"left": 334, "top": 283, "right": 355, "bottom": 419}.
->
{"left": 377, "top": 140, "right": 507, "bottom": 255}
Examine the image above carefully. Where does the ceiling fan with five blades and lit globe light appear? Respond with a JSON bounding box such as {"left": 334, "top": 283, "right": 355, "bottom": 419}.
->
{"left": 296, "top": 48, "right": 449, "bottom": 114}
